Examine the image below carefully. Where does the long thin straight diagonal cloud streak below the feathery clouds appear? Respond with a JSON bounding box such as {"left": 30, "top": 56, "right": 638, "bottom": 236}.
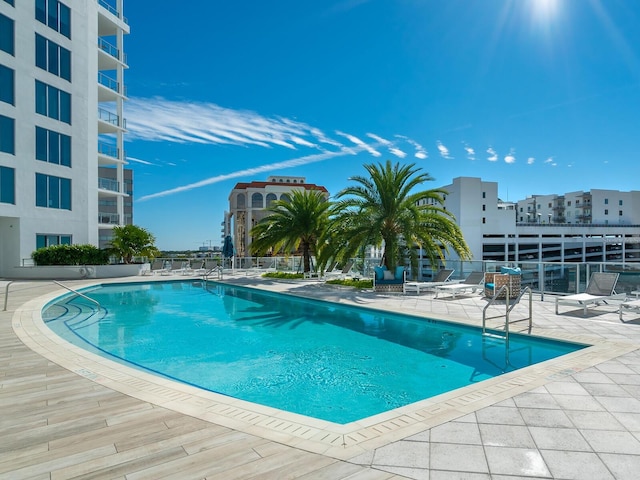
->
{"left": 138, "top": 147, "right": 362, "bottom": 202}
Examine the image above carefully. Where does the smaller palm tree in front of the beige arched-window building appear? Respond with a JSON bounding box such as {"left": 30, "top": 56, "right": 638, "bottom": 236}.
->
{"left": 250, "top": 190, "right": 330, "bottom": 272}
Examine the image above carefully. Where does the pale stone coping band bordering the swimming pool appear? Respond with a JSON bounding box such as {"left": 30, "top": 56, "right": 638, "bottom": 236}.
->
{"left": 12, "top": 279, "right": 637, "bottom": 460}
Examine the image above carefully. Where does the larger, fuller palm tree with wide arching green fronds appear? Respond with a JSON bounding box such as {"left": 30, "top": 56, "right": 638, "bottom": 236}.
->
{"left": 322, "top": 160, "right": 471, "bottom": 271}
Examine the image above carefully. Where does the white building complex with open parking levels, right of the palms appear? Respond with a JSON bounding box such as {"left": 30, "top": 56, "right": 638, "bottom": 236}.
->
{"left": 428, "top": 177, "right": 640, "bottom": 263}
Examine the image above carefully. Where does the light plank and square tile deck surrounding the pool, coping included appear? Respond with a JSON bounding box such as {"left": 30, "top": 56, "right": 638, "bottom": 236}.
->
{"left": 0, "top": 276, "right": 640, "bottom": 480}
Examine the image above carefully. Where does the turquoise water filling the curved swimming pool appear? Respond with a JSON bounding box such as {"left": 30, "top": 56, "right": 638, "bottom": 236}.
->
{"left": 42, "top": 280, "right": 584, "bottom": 424}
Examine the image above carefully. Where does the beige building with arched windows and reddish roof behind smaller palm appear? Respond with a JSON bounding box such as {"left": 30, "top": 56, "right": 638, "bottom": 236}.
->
{"left": 222, "top": 176, "right": 329, "bottom": 257}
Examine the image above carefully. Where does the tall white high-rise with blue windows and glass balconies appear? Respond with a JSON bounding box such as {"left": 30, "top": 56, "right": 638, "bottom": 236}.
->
{"left": 0, "top": 0, "right": 132, "bottom": 276}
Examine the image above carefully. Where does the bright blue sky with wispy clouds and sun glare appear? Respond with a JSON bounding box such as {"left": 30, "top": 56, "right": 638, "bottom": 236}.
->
{"left": 125, "top": 0, "right": 640, "bottom": 250}
